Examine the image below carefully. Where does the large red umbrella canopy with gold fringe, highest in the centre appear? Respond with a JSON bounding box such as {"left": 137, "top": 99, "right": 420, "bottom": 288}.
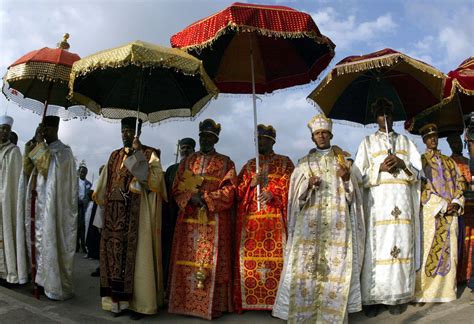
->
{"left": 171, "top": 3, "right": 335, "bottom": 93}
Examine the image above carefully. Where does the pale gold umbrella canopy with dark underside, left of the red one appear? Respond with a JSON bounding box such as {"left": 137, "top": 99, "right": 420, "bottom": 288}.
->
{"left": 69, "top": 41, "right": 218, "bottom": 123}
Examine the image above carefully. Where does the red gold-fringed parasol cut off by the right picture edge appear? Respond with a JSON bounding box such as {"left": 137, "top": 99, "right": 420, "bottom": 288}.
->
{"left": 405, "top": 57, "right": 474, "bottom": 137}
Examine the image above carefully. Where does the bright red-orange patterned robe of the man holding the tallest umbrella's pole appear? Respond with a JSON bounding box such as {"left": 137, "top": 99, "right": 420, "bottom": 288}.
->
{"left": 234, "top": 153, "right": 294, "bottom": 312}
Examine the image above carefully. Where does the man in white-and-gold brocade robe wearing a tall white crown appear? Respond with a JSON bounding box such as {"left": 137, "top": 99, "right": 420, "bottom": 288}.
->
{"left": 273, "top": 115, "right": 365, "bottom": 323}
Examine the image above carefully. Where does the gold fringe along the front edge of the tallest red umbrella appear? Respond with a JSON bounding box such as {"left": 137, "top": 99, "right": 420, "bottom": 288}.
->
{"left": 179, "top": 22, "right": 335, "bottom": 56}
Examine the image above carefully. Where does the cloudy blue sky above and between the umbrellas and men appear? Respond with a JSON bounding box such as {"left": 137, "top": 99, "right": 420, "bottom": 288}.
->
{"left": 0, "top": 0, "right": 474, "bottom": 181}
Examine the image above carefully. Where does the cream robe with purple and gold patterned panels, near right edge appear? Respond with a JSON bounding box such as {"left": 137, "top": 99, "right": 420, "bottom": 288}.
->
{"left": 415, "top": 150, "right": 464, "bottom": 302}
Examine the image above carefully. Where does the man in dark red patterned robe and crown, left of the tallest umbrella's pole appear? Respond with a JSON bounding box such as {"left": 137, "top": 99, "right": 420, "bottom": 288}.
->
{"left": 168, "top": 119, "right": 237, "bottom": 320}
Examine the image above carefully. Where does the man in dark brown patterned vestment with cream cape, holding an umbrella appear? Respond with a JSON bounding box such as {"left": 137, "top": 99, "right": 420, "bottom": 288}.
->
{"left": 93, "top": 117, "right": 167, "bottom": 318}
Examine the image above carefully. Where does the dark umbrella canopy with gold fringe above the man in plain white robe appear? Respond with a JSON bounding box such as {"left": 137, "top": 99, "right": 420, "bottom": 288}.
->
{"left": 308, "top": 48, "right": 446, "bottom": 125}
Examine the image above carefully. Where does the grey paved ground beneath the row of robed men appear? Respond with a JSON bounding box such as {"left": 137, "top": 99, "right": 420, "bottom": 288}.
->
{"left": 0, "top": 254, "right": 474, "bottom": 324}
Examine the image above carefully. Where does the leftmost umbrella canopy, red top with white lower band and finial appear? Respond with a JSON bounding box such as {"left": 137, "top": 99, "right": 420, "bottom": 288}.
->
{"left": 2, "top": 34, "right": 85, "bottom": 119}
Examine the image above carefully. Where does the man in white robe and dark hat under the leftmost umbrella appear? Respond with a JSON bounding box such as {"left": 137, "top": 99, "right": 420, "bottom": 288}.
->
{"left": 19, "top": 116, "right": 78, "bottom": 300}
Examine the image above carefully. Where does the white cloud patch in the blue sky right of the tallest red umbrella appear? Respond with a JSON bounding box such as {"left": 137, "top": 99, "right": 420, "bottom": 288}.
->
{"left": 312, "top": 7, "right": 397, "bottom": 50}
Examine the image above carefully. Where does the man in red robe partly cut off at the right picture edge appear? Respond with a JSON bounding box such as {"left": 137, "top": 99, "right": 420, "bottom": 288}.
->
{"left": 446, "top": 134, "right": 474, "bottom": 283}
